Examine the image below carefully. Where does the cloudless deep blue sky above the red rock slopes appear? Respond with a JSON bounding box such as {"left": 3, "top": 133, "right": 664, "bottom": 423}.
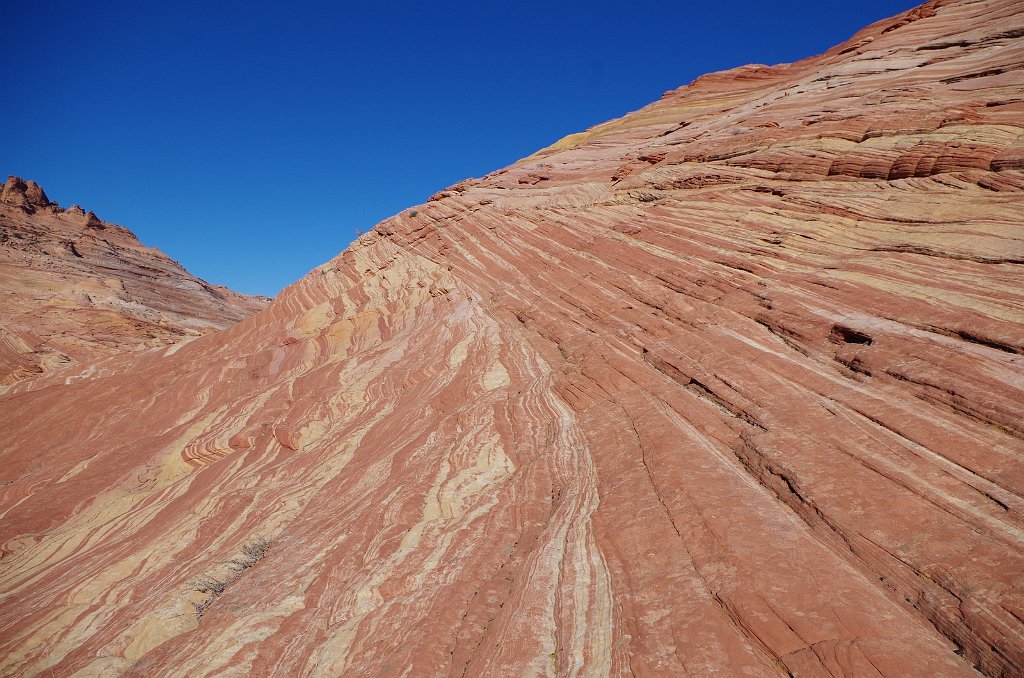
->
{"left": 0, "top": 0, "right": 916, "bottom": 295}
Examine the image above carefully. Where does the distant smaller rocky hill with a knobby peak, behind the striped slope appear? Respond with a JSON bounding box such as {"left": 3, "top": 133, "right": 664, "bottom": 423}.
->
{"left": 0, "top": 176, "right": 269, "bottom": 388}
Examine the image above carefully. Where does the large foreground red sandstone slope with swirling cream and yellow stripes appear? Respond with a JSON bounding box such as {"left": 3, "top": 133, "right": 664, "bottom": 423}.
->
{"left": 0, "top": 0, "right": 1024, "bottom": 676}
